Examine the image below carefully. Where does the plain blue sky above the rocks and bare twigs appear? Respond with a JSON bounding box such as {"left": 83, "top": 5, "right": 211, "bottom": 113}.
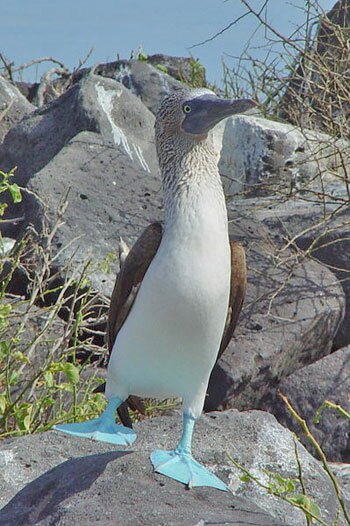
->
{"left": 0, "top": 0, "right": 335, "bottom": 85}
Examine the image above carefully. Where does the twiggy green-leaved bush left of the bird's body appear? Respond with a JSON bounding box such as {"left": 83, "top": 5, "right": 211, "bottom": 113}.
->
{"left": 0, "top": 188, "right": 107, "bottom": 438}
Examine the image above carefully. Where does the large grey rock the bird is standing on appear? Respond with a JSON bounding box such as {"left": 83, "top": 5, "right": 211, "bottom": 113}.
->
{"left": 0, "top": 411, "right": 344, "bottom": 526}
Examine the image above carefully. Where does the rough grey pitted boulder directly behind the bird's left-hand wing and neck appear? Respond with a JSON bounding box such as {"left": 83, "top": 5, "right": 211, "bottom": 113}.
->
{"left": 26, "top": 132, "right": 162, "bottom": 296}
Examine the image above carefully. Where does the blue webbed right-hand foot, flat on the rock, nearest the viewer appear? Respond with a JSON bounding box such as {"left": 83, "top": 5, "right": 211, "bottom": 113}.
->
{"left": 151, "top": 449, "right": 228, "bottom": 491}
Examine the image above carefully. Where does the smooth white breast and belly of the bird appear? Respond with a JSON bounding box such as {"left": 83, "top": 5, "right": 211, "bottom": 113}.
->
{"left": 107, "top": 184, "right": 231, "bottom": 416}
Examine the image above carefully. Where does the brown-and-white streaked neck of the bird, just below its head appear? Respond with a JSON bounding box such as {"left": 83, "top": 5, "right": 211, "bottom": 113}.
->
{"left": 160, "top": 138, "right": 227, "bottom": 235}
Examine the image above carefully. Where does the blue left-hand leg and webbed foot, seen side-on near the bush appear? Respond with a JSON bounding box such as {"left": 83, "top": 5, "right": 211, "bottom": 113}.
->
{"left": 53, "top": 397, "right": 136, "bottom": 446}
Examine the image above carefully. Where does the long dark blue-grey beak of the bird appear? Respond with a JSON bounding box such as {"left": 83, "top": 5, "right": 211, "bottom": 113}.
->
{"left": 182, "top": 95, "right": 257, "bottom": 135}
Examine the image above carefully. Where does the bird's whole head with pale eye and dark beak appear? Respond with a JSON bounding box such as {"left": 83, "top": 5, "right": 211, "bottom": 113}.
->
{"left": 155, "top": 88, "right": 256, "bottom": 141}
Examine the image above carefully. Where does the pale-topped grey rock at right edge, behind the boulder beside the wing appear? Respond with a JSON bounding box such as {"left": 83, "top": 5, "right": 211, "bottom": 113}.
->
{"left": 238, "top": 197, "right": 350, "bottom": 350}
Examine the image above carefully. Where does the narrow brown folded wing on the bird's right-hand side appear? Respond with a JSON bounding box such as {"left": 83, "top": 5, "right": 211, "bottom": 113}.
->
{"left": 218, "top": 240, "right": 247, "bottom": 359}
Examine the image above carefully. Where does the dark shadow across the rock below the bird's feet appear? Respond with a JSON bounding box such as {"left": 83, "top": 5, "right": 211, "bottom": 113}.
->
{"left": 0, "top": 451, "right": 131, "bottom": 526}
